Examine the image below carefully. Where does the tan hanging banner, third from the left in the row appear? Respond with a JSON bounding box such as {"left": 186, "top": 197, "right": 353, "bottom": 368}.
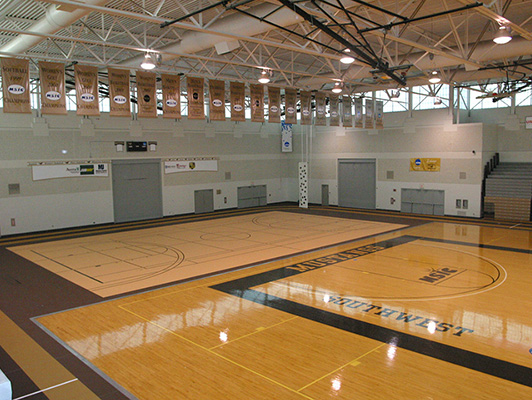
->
{"left": 74, "top": 64, "right": 100, "bottom": 117}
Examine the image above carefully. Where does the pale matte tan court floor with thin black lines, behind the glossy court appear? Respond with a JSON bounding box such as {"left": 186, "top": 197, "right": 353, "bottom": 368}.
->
{"left": 9, "top": 211, "right": 404, "bottom": 297}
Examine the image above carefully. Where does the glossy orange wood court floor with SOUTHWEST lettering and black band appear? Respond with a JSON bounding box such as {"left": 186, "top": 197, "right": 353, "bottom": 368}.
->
{"left": 36, "top": 216, "right": 532, "bottom": 400}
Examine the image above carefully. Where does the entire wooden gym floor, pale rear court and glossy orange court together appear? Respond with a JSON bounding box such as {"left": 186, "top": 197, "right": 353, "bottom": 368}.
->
{"left": 7, "top": 212, "right": 532, "bottom": 400}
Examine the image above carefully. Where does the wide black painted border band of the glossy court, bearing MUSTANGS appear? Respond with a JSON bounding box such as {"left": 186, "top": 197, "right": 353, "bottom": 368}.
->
{"left": 210, "top": 236, "right": 532, "bottom": 387}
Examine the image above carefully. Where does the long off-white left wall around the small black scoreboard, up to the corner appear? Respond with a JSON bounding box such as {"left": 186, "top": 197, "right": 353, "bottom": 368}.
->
{"left": 0, "top": 109, "right": 290, "bottom": 235}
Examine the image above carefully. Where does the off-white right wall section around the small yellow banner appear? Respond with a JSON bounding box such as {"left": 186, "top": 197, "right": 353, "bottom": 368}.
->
{"left": 302, "top": 110, "right": 483, "bottom": 217}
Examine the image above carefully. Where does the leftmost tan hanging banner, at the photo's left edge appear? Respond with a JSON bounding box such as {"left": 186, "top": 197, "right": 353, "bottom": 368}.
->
{"left": 0, "top": 58, "right": 31, "bottom": 114}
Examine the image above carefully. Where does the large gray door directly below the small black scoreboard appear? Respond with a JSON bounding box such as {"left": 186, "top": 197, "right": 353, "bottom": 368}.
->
{"left": 111, "top": 160, "right": 163, "bottom": 222}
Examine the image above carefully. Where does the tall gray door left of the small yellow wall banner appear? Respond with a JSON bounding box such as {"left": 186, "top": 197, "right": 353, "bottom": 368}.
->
{"left": 338, "top": 158, "right": 377, "bottom": 210}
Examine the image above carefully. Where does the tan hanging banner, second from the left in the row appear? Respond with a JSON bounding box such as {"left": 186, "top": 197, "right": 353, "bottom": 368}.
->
{"left": 39, "top": 61, "right": 67, "bottom": 115}
